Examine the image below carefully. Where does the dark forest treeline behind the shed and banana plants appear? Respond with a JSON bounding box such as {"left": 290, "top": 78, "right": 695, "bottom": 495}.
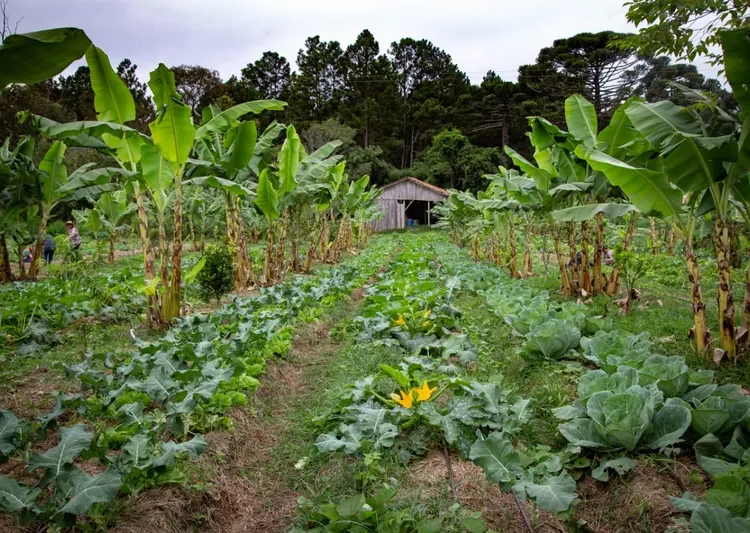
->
{"left": 0, "top": 30, "right": 736, "bottom": 190}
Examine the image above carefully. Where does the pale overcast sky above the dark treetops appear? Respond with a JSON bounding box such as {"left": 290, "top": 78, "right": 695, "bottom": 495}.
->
{"left": 9, "top": 0, "right": 716, "bottom": 83}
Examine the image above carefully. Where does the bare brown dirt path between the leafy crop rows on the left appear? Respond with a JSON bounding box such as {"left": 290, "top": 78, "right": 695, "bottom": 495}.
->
{"left": 114, "top": 289, "right": 362, "bottom": 533}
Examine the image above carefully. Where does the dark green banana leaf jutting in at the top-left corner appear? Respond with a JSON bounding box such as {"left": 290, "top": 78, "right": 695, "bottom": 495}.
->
{"left": 0, "top": 28, "right": 91, "bottom": 90}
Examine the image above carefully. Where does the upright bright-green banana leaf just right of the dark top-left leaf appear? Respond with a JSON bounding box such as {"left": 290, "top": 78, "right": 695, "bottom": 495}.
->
{"left": 86, "top": 45, "right": 135, "bottom": 124}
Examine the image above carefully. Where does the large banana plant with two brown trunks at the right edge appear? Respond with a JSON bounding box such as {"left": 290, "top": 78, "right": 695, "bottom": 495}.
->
{"left": 577, "top": 95, "right": 750, "bottom": 361}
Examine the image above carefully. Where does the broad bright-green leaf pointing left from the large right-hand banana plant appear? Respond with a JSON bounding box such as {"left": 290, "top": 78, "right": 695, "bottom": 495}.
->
{"left": 576, "top": 146, "right": 682, "bottom": 217}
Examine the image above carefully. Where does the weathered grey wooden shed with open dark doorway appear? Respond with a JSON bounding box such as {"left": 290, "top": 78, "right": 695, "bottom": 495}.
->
{"left": 373, "top": 177, "right": 449, "bottom": 231}
